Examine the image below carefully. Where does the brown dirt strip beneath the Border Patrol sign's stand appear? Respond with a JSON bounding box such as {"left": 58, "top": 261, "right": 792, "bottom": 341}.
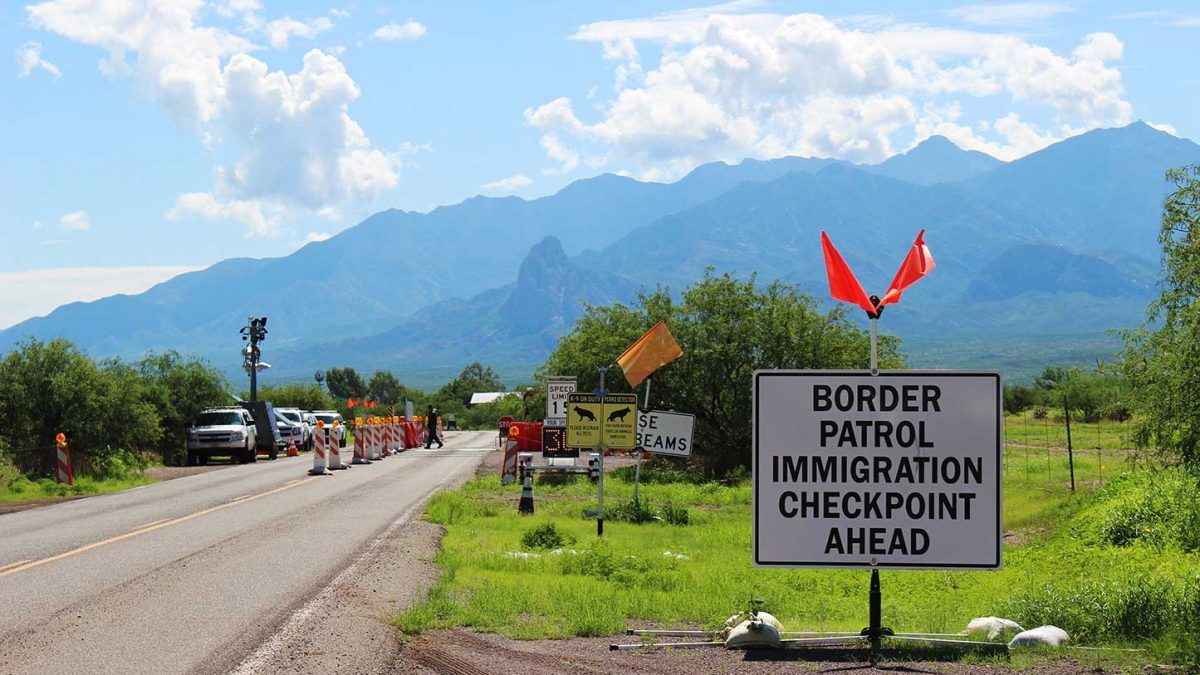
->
{"left": 395, "top": 628, "right": 1118, "bottom": 675}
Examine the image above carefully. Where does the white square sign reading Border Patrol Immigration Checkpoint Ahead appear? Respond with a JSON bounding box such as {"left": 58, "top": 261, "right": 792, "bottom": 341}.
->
{"left": 754, "top": 370, "right": 1003, "bottom": 569}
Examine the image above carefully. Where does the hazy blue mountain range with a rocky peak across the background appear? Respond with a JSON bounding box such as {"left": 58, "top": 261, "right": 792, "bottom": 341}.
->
{"left": 0, "top": 123, "right": 1200, "bottom": 386}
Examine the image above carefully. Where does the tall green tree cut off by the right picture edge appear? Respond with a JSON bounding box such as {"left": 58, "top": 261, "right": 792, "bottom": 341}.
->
{"left": 1121, "top": 165, "right": 1200, "bottom": 467}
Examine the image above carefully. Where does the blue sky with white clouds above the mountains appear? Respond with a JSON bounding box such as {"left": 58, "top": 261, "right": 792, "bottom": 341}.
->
{"left": 0, "top": 0, "right": 1200, "bottom": 327}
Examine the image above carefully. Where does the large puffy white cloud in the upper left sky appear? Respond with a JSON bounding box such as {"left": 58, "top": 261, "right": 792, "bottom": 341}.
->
{"left": 26, "top": 0, "right": 398, "bottom": 235}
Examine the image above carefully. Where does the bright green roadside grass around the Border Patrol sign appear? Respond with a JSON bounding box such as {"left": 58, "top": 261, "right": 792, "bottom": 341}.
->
{"left": 395, "top": 456, "right": 1200, "bottom": 658}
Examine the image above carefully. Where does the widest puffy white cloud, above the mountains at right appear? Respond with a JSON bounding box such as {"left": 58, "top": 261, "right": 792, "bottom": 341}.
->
{"left": 524, "top": 9, "right": 1133, "bottom": 179}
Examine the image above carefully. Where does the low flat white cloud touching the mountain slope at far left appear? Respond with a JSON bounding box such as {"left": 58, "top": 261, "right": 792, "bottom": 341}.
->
{"left": 0, "top": 264, "right": 200, "bottom": 329}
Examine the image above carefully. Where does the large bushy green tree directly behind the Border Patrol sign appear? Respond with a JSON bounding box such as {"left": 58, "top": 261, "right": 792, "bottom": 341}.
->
{"left": 539, "top": 270, "right": 905, "bottom": 476}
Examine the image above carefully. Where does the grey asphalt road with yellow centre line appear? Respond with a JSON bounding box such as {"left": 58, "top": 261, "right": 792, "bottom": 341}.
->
{"left": 0, "top": 432, "right": 496, "bottom": 673}
